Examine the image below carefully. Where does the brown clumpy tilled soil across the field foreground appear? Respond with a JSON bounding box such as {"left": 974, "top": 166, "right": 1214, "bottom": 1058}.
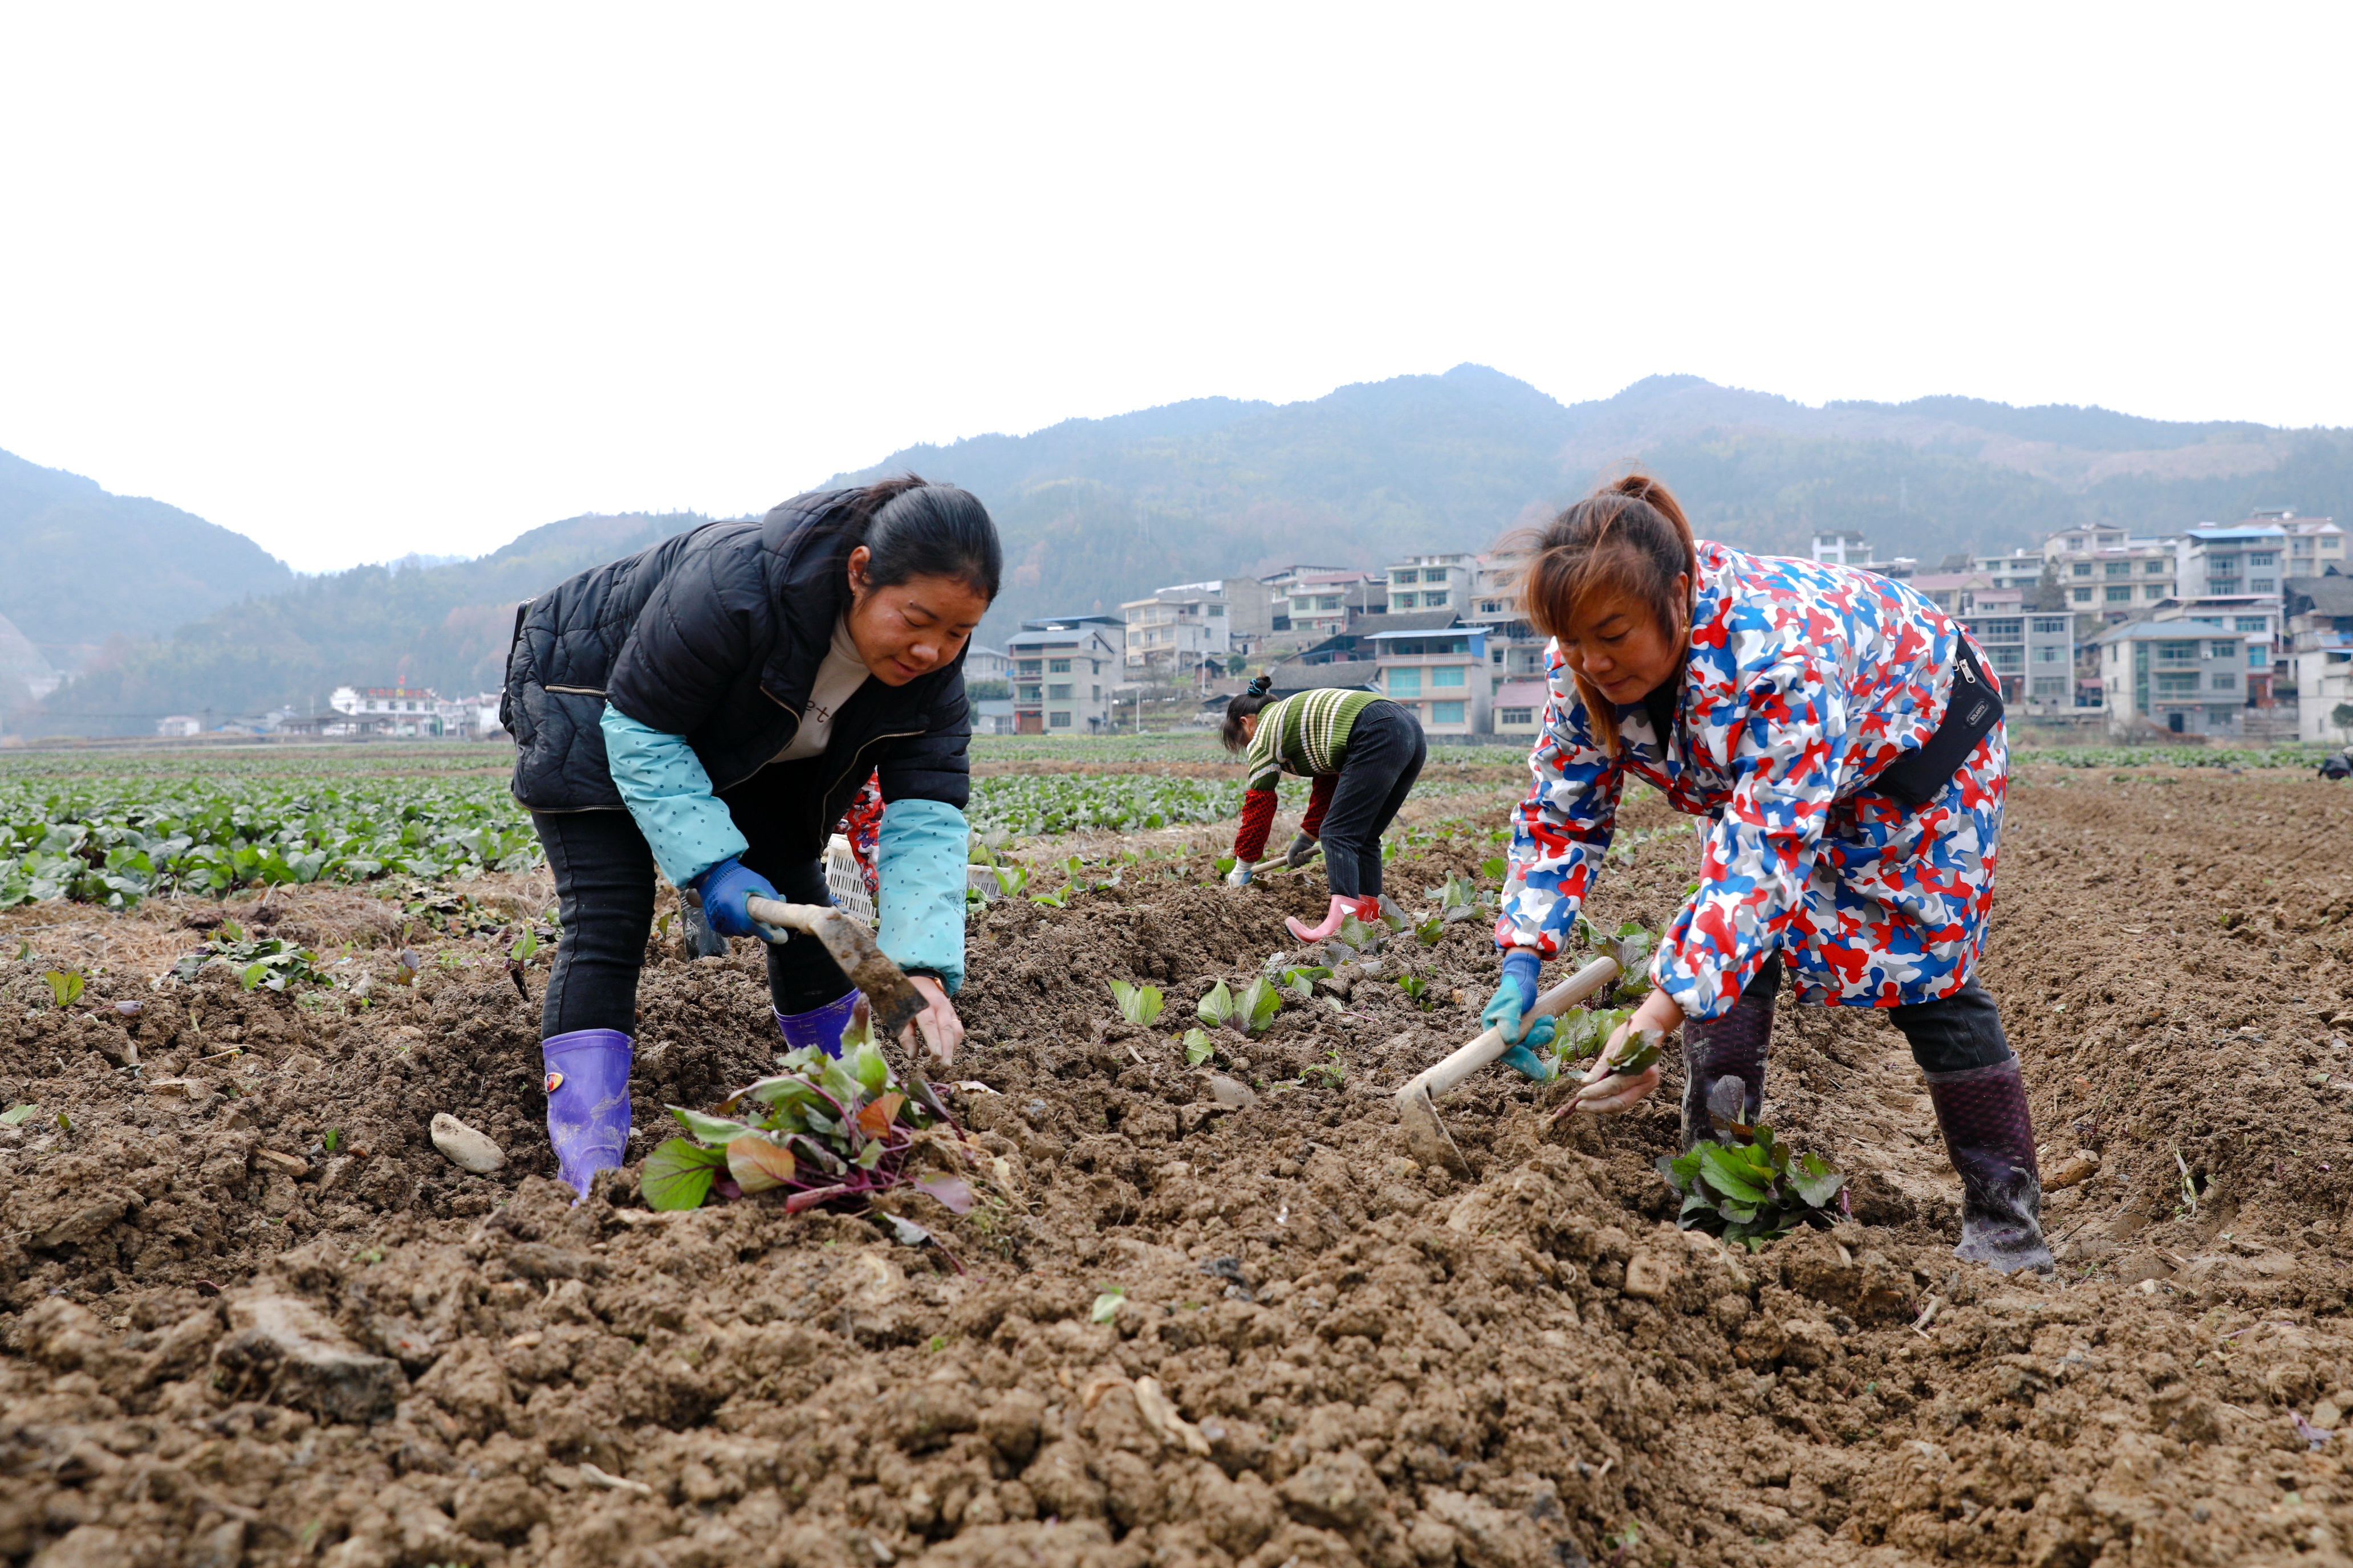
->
{"left": 0, "top": 769, "right": 2353, "bottom": 1568}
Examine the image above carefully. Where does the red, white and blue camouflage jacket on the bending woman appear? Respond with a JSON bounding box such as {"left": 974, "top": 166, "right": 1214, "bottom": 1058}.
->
{"left": 1494, "top": 543, "right": 2009, "bottom": 1018}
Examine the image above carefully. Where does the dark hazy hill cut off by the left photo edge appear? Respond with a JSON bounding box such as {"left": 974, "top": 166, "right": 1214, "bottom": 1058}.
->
{"left": 0, "top": 451, "right": 294, "bottom": 670}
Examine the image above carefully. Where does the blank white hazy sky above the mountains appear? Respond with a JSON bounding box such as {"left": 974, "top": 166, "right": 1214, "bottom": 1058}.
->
{"left": 0, "top": 0, "right": 2353, "bottom": 569}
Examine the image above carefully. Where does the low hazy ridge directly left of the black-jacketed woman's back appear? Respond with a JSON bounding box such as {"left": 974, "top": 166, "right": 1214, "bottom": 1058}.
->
{"left": 10, "top": 512, "right": 706, "bottom": 736}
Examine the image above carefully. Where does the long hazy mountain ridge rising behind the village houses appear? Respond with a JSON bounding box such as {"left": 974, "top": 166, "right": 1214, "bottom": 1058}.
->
{"left": 835, "top": 364, "right": 2353, "bottom": 637}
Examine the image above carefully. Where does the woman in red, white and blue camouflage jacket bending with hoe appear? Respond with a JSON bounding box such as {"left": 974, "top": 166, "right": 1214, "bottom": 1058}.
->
{"left": 1485, "top": 475, "right": 2052, "bottom": 1272}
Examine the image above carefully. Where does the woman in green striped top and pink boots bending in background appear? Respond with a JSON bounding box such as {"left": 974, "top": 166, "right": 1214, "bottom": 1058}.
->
{"left": 1224, "top": 675, "right": 1428, "bottom": 943}
